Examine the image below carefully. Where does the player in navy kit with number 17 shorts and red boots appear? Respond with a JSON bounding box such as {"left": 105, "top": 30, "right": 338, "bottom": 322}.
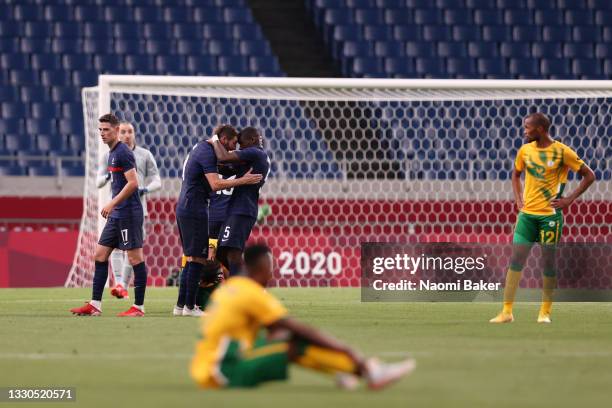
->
{"left": 70, "top": 113, "right": 147, "bottom": 317}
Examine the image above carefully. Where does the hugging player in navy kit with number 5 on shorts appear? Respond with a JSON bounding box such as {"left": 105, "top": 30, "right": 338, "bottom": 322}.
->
{"left": 210, "top": 127, "right": 270, "bottom": 276}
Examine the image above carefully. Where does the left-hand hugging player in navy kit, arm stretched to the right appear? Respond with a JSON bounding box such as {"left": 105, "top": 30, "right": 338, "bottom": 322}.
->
{"left": 176, "top": 125, "right": 262, "bottom": 316}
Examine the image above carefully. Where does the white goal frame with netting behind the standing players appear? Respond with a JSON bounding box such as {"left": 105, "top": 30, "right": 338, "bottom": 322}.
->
{"left": 66, "top": 76, "right": 612, "bottom": 286}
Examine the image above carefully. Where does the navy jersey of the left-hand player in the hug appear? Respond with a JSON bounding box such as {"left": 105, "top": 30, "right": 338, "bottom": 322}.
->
{"left": 176, "top": 140, "right": 217, "bottom": 217}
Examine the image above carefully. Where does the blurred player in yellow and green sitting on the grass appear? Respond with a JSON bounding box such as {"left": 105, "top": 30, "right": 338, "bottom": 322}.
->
{"left": 191, "top": 245, "right": 415, "bottom": 389}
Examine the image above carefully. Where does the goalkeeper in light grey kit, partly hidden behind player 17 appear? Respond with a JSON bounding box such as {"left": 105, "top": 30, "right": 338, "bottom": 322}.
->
{"left": 96, "top": 121, "right": 161, "bottom": 299}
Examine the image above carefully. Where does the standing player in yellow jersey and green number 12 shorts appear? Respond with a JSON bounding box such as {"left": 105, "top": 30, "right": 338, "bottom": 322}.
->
{"left": 490, "top": 113, "right": 595, "bottom": 323}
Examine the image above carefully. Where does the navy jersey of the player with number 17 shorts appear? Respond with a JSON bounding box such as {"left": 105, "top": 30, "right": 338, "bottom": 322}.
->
{"left": 108, "top": 142, "right": 143, "bottom": 218}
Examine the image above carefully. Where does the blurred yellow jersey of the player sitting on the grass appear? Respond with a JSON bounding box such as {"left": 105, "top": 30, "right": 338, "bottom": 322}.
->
{"left": 191, "top": 276, "right": 287, "bottom": 387}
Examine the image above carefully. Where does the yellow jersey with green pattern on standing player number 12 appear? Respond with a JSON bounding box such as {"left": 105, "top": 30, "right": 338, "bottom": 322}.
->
{"left": 514, "top": 141, "right": 584, "bottom": 215}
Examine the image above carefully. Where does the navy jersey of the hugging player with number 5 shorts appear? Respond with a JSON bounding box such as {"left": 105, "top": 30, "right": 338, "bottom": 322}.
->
{"left": 227, "top": 146, "right": 270, "bottom": 218}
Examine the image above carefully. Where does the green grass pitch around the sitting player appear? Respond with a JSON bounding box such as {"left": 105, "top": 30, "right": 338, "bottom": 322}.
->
{"left": 0, "top": 288, "right": 612, "bottom": 408}
